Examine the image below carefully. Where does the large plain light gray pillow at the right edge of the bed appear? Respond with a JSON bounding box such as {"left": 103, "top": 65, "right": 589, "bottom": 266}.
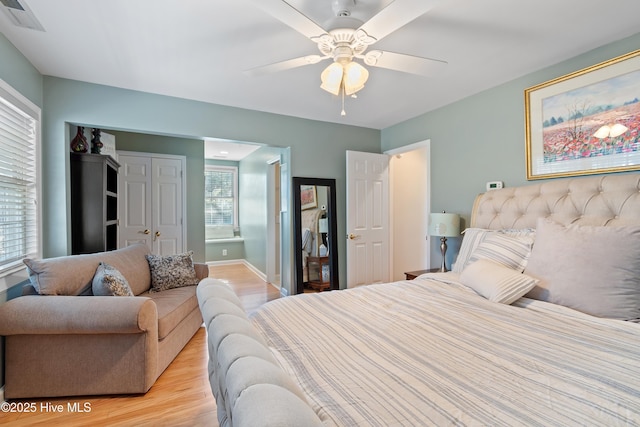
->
{"left": 524, "top": 219, "right": 640, "bottom": 321}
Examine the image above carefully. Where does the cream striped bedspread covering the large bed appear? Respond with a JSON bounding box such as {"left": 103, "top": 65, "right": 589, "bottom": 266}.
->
{"left": 252, "top": 273, "right": 640, "bottom": 427}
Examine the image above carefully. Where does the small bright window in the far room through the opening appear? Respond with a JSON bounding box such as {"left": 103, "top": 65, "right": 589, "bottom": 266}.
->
{"left": 204, "top": 166, "right": 238, "bottom": 227}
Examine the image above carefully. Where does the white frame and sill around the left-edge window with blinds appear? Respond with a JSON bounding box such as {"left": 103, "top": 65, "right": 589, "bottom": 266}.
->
{"left": 0, "top": 79, "right": 42, "bottom": 291}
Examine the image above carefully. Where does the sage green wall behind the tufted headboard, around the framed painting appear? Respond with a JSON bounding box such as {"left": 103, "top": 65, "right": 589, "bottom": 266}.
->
{"left": 381, "top": 33, "right": 640, "bottom": 265}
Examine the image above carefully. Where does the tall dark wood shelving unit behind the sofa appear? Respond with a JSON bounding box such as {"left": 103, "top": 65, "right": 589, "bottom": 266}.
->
{"left": 70, "top": 153, "right": 120, "bottom": 255}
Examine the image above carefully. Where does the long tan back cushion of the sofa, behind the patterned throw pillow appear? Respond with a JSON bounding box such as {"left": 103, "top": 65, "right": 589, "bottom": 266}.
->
{"left": 24, "top": 244, "right": 151, "bottom": 295}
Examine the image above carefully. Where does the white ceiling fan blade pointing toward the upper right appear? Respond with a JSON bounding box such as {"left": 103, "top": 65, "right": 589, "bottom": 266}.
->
{"left": 359, "top": 0, "right": 442, "bottom": 41}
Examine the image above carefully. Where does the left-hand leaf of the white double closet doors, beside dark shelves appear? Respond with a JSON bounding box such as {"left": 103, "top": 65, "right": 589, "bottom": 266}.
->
{"left": 118, "top": 155, "right": 153, "bottom": 249}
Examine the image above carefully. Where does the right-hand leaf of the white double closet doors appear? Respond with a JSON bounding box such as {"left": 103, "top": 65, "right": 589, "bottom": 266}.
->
{"left": 151, "top": 158, "right": 184, "bottom": 255}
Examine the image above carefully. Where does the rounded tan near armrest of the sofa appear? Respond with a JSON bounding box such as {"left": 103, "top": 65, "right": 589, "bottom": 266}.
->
{"left": 0, "top": 295, "right": 158, "bottom": 336}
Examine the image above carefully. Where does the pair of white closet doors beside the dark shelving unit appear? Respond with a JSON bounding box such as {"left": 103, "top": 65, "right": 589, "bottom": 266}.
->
{"left": 118, "top": 152, "right": 185, "bottom": 255}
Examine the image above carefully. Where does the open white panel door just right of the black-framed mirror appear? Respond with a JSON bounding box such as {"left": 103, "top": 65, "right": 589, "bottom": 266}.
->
{"left": 347, "top": 151, "right": 391, "bottom": 288}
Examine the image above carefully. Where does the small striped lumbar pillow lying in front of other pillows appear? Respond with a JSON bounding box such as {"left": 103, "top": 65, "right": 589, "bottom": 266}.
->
{"left": 460, "top": 259, "right": 538, "bottom": 304}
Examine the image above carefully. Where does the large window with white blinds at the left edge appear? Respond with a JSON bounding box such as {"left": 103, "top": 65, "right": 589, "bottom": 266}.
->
{"left": 0, "top": 80, "right": 40, "bottom": 277}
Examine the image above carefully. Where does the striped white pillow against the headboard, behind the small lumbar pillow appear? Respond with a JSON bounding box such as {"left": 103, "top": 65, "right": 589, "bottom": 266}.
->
{"left": 465, "top": 233, "right": 533, "bottom": 273}
